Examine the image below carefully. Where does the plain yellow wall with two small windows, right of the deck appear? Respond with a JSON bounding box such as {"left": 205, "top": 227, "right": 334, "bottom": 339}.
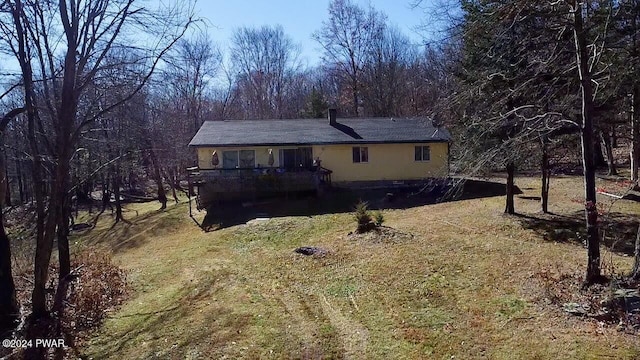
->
{"left": 313, "top": 142, "right": 449, "bottom": 182}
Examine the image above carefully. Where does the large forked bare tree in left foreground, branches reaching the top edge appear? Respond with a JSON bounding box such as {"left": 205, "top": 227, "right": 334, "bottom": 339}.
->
{"left": 0, "top": 0, "right": 192, "bottom": 318}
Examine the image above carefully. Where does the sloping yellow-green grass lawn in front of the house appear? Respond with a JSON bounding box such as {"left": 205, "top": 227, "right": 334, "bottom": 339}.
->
{"left": 79, "top": 177, "right": 640, "bottom": 359}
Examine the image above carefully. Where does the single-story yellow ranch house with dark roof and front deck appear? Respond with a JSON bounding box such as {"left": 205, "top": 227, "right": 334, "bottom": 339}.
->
{"left": 189, "top": 109, "right": 450, "bottom": 206}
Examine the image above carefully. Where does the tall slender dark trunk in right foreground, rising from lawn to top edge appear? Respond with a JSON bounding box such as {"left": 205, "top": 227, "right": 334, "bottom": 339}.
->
{"left": 573, "top": 1, "right": 601, "bottom": 285}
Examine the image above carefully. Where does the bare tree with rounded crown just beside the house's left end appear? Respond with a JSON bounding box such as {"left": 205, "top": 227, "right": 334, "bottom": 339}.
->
{"left": 154, "top": 33, "right": 222, "bottom": 198}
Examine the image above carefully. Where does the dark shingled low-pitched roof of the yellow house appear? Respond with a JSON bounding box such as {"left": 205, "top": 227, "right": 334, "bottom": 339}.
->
{"left": 189, "top": 118, "right": 451, "bottom": 146}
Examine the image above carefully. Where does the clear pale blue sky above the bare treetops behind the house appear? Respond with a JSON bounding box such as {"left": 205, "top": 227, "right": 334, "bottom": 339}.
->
{"left": 196, "top": 0, "right": 436, "bottom": 66}
